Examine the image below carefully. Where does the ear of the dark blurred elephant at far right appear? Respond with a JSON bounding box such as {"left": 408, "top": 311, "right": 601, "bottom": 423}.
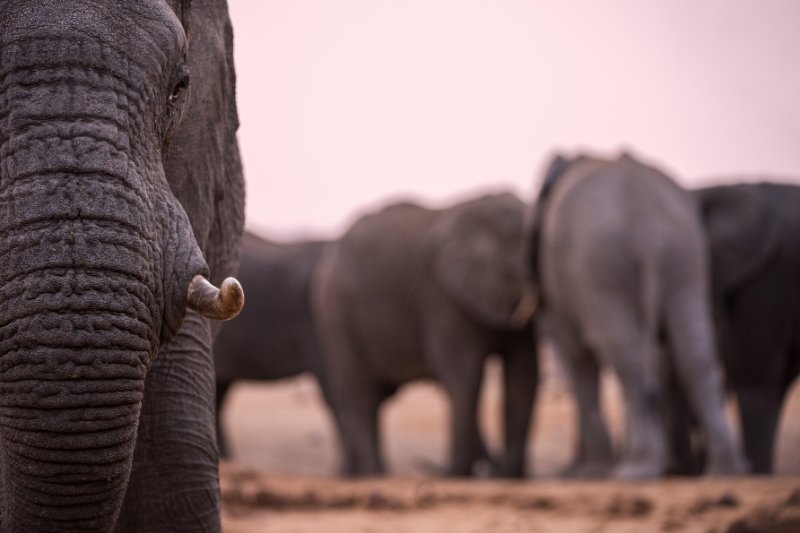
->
{"left": 698, "top": 185, "right": 780, "bottom": 293}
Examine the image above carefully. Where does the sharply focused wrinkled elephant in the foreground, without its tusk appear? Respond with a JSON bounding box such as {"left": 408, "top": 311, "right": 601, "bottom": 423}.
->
{"left": 0, "top": 0, "right": 244, "bottom": 532}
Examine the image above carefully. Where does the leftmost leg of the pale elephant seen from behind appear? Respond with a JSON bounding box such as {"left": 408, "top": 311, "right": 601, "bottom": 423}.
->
{"left": 552, "top": 316, "right": 613, "bottom": 478}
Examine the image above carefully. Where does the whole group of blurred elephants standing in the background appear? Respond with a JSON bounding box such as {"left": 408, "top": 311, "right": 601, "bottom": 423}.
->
{"left": 214, "top": 154, "right": 800, "bottom": 479}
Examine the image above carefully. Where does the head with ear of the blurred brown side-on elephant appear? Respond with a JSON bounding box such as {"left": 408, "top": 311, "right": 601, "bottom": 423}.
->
{"left": 432, "top": 194, "right": 534, "bottom": 329}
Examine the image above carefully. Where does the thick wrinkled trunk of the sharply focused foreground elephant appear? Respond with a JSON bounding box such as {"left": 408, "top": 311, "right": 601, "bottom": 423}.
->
{"left": 0, "top": 158, "right": 161, "bottom": 531}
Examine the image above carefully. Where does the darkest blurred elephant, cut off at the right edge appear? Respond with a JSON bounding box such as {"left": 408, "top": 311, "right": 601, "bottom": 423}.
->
{"left": 674, "top": 183, "right": 800, "bottom": 474}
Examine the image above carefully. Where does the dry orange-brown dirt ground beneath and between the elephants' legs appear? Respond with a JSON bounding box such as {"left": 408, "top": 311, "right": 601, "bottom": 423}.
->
{"left": 221, "top": 354, "right": 800, "bottom": 533}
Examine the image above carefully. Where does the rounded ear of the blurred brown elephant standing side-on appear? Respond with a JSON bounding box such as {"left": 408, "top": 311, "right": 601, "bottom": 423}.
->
{"left": 434, "top": 200, "right": 524, "bottom": 328}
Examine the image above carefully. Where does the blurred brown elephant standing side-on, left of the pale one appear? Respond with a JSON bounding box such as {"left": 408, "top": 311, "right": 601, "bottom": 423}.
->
{"left": 312, "top": 194, "right": 537, "bottom": 476}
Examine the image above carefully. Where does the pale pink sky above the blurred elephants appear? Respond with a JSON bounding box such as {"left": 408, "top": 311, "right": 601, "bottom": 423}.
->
{"left": 229, "top": 0, "right": 800, "bottom": 238}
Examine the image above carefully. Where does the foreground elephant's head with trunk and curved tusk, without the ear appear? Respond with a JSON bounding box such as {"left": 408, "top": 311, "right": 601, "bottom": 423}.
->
{"left": 0, "top": 0, "right": 243, "bottom": 531}
